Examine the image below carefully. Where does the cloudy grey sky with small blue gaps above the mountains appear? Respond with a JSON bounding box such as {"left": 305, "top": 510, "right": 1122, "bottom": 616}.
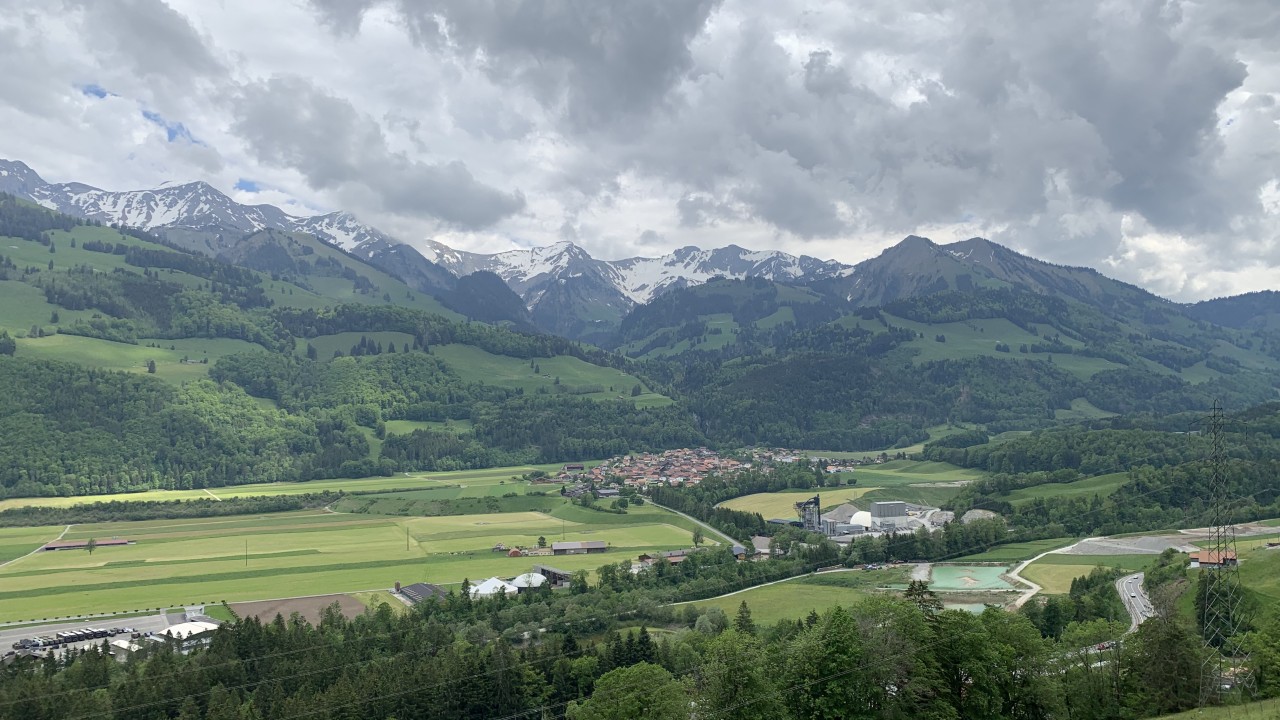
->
{"left": 0, "top": 0, "right": 1280, "bottom": 300}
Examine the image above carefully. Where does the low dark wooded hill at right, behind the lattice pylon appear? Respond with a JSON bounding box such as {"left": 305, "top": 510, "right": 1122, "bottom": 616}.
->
{"left": 924, "top": 404, "right": 1280, "bottom": 537}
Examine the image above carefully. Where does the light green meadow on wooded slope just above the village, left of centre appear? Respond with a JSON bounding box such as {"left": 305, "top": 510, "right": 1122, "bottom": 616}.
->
{"left": 430, "top": 338, "right": 671, "bottom": 407}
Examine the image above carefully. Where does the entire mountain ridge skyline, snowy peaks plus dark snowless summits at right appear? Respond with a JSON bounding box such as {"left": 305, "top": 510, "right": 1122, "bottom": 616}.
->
{"left": 0, "top": 160, "right": 1280, "bottom": 346}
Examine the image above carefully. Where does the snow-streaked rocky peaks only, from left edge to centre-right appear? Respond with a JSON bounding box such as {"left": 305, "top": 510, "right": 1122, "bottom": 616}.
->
{"left": 0, "top": 160, "right": 849, "bottom": 340}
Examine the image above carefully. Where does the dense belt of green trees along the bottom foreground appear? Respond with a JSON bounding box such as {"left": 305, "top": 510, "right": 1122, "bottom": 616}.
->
{"left": 10, "top": 548, "right": 1280, "bottom": 720}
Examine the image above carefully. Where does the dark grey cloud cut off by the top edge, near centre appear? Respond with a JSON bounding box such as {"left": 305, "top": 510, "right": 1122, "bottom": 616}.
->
{"left": 312, "top": 0, "right": 719, "bottom": 129}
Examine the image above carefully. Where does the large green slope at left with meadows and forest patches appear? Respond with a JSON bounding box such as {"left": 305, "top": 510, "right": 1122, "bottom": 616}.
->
{"left": 0, "top": 201, "right": 704, "bottom": 496}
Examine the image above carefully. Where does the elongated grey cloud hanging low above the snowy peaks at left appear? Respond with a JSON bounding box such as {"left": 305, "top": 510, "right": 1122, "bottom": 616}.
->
{"left": 234, "top": 78, "right": 525, "bottom": 229}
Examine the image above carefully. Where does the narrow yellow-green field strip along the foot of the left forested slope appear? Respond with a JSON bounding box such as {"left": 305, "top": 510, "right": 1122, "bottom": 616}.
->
{"left": 0, "top": 462, "right": 594, "bottom": 510}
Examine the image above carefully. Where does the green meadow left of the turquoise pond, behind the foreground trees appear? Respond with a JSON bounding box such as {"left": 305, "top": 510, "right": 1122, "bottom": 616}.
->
{"left": 692, "top": 568, "right": 906, "bottom": 625}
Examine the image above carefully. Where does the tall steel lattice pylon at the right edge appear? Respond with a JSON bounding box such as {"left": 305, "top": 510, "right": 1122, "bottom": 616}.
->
{"left": 1197, "top": 401, "right": 1253, "bottom": 707}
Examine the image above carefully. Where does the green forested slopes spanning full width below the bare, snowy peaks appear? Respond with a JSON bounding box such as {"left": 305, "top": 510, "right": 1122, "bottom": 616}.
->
{"left": 0, "top": 197, "right": 1280, "bottom": 496}
